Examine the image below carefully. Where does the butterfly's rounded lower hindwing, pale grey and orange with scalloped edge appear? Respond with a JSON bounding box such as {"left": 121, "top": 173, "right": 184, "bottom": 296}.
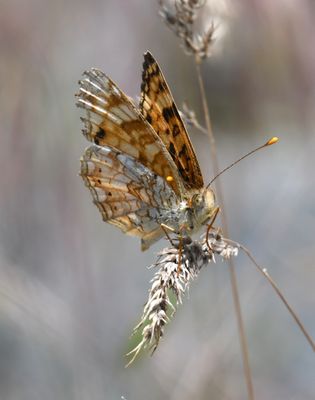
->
{"left": 81, "top": 145, "right": 177, "bottom": 237}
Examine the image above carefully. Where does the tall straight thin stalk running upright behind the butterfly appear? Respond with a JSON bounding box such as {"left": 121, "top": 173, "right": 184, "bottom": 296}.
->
{"left": 195, "top": 55, "right": 255, "bottom": 400}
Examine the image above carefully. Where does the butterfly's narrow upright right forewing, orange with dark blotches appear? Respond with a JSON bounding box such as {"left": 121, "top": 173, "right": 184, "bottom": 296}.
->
{"left": 140, "top": 52, "right": 204, "bottom": 189}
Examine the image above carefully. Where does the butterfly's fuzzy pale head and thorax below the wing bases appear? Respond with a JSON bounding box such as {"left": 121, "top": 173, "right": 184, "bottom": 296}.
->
{"left": 159, "top": 189, "right": 215, "bottom": 234}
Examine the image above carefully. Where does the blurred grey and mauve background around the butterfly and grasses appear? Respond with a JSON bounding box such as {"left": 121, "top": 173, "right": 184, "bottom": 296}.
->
{"left": 0, "top": 0, "right": 315, "bottom": 400}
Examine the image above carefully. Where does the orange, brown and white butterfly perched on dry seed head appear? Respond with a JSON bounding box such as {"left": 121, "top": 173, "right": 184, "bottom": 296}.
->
{"left": 76, "top": 52, "right": 216, "bottom": 250}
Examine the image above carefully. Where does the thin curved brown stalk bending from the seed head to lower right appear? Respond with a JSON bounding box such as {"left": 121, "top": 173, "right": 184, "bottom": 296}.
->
{"left": 228, "top": 239, "right": 315, "bottom": 352}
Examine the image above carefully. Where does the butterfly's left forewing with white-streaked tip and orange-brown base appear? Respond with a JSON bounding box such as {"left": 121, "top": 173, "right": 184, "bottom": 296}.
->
{"left": 76, "top": 68, "right": 184, "bottom": 197}
